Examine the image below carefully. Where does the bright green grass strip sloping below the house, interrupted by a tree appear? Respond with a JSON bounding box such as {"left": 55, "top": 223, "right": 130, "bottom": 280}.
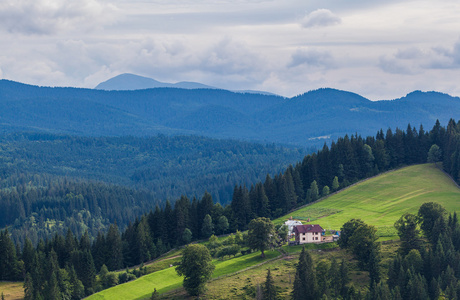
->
{"left": 87, "top": 251, "right": 280, "bottom": 300}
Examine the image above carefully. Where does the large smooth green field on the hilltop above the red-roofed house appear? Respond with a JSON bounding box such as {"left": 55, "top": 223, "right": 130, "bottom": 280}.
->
{"left": 275, "top": 164, "right": 460, "bottom": 239}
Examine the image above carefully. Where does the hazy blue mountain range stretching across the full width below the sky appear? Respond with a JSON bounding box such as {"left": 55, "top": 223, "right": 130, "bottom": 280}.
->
{"left": 0, "top": 80, "right": 460, "bottom": 146}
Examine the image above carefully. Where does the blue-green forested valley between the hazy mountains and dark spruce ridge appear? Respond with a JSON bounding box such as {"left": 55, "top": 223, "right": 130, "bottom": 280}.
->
{"left": 0, "top": 133, "right": 302, "bottom": 244}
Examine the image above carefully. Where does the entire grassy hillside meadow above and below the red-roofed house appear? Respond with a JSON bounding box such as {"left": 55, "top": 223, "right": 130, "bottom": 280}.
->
{"left": 88, "top": 164, "right": 460, "bottom": 299}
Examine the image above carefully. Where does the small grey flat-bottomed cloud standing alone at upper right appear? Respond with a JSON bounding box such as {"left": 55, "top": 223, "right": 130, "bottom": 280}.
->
{"left": 288, "top": 49, "right": 335, "bottom": 68}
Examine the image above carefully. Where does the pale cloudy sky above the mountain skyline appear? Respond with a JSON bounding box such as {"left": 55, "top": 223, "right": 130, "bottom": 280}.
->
{"left": 0, "top": 0, "right": 460, "bottom": 100}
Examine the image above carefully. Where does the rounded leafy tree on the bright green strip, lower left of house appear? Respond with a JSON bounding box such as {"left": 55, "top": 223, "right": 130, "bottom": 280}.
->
{"left": 176, "top": 244, "right": 215, "bottom": 296}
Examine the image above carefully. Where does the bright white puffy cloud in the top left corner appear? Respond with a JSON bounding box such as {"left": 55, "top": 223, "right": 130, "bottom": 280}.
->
{"left": 0, "top": 0, "right": 117, "bottom": 35}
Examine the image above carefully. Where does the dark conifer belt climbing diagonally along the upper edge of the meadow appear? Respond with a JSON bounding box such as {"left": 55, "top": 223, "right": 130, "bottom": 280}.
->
{"left": 0, "top": 120, "right": 460, "bottom": 296}
